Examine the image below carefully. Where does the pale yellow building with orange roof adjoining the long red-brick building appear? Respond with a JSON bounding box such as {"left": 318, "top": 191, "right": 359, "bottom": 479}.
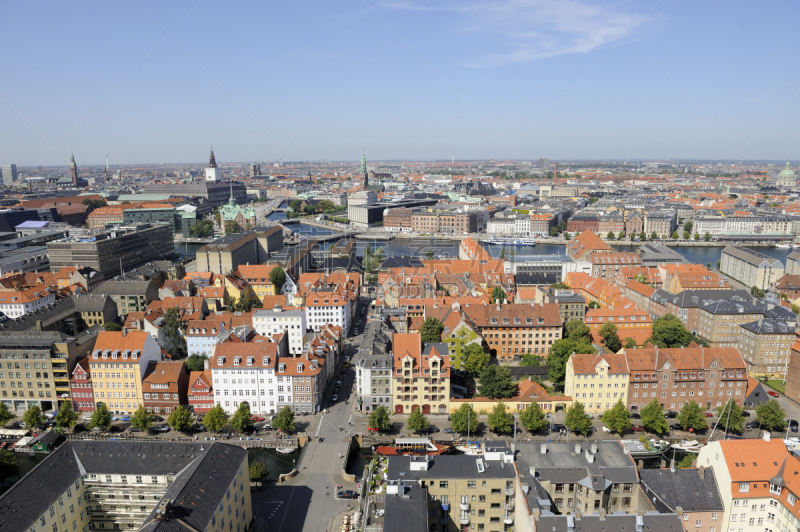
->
{"left": 564, "top": 353, "right": 630, "bottom": 414}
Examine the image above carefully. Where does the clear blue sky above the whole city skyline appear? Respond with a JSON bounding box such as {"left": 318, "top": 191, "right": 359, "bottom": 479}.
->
{"left": 0, "top": 0, "right": 800, "bottom": 166}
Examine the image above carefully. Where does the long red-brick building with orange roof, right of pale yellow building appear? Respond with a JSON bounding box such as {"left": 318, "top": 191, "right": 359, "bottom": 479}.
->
{"left": 625, "top": 347, "right": 747, "bottom": 412}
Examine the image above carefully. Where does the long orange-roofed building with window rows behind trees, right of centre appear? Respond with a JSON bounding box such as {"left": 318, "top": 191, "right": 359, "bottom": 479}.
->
{"left": 463, "top": 303, "right": 563, "bottom": 361}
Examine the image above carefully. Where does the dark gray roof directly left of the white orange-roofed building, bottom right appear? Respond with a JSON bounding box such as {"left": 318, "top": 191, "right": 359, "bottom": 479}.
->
{"left": 639, "top": 468, "right": 725, "bottom": 512}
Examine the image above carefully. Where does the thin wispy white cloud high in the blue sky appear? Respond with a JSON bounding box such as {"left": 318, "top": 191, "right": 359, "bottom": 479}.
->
{"left": 382, "top": 0, "right": 648, "bottom": 67}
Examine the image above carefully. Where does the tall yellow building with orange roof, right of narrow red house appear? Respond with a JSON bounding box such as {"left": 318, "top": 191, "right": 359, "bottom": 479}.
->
{"left": 89, "top": 331, "right": 161, "bottom": 415}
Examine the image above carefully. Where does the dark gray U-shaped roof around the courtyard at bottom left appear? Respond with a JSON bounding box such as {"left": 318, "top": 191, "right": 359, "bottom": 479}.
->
{"left": 0, "top": 440, "right": 247, "bottom": 532}
